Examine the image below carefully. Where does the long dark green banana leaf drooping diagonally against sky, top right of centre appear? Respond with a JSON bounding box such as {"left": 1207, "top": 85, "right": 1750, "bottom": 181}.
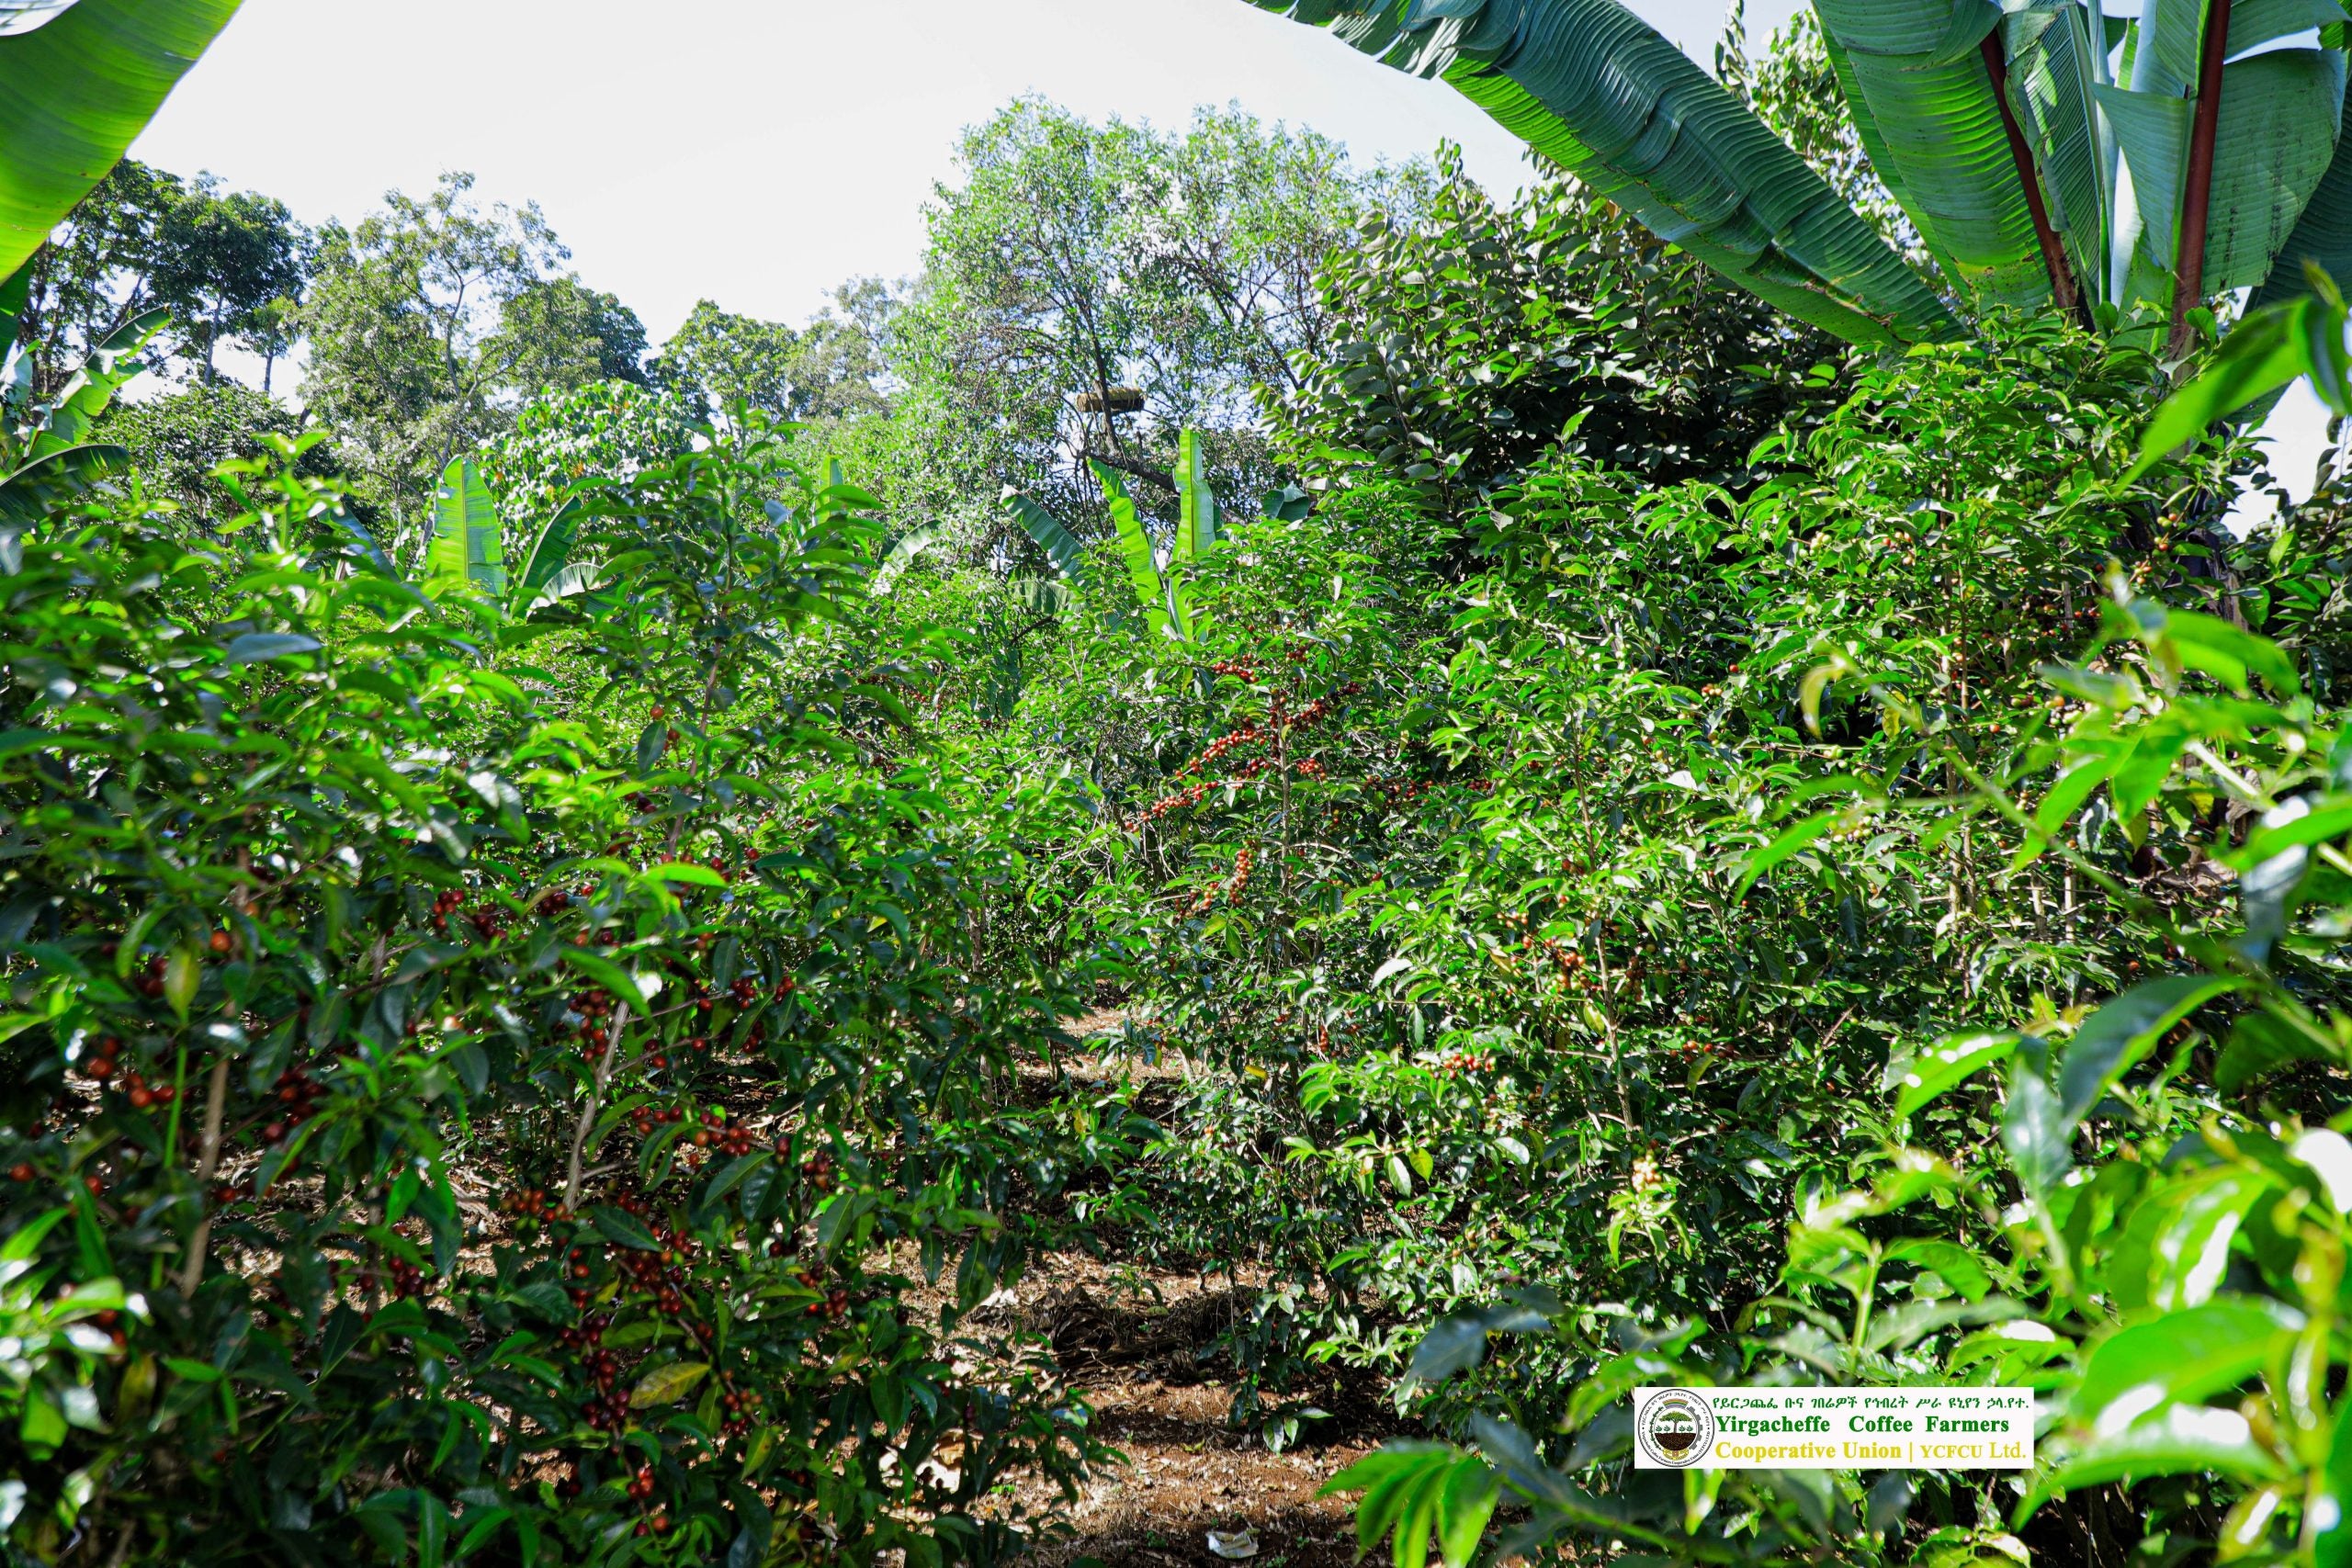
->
{"left": 1253, "top": 0, "right": 1959, "bottom": 344}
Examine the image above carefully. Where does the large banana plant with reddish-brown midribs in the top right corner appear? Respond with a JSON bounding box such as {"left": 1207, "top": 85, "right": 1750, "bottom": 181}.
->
{"left": 1251, "top": 0, "right": 2352, "bottom": 353}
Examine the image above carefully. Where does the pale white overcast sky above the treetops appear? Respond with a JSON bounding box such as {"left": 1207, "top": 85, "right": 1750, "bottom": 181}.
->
{"left": 131, "top": 0, "right": 2317, "bottom": 491}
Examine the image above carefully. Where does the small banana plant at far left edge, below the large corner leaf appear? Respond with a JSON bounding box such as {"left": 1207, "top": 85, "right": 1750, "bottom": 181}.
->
{"left": 0, "top": 265, "right": 172, "bottom": 526}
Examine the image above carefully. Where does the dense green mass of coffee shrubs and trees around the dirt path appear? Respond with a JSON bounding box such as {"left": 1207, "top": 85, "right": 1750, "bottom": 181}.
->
{"left": 0, "top": 3, "right": 2352, "bottom": 1568}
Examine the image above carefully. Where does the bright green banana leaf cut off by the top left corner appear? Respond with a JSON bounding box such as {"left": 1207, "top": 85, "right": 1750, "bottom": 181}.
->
{"left": 0, "top": 0, "right": 238, "bottom": 275}
